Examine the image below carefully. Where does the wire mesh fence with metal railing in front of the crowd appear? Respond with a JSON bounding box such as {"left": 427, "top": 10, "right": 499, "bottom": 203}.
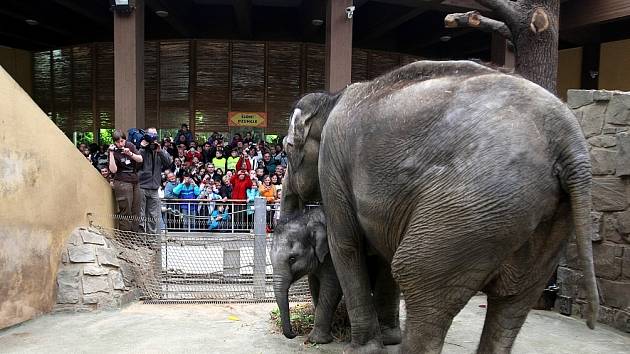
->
{"left": 91, "top": 198, "right": 310, "bottom": 302}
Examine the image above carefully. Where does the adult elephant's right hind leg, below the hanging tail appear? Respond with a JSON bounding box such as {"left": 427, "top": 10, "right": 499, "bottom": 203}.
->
{"left": 477, "top": 204, "right": 571, "bottom": 353}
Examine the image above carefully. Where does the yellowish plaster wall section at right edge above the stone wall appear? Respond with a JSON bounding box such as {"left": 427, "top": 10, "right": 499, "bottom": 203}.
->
{"left": 599, "top": 39, "right": 630, "bottom": 91}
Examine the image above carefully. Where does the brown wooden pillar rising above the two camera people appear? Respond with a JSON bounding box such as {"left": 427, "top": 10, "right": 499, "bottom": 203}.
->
{"left": 114, "top": 0, "right": 146, "bottom": 131}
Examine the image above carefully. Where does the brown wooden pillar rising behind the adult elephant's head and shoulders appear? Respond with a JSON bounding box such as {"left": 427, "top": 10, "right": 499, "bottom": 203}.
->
{"left": 326, "top": 0, "right": 352, "bottom": 93}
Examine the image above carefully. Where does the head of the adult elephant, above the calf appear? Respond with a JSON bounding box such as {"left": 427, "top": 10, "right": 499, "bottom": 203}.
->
{"left": 282, "top": 92, "right": 339, "bottom": 215}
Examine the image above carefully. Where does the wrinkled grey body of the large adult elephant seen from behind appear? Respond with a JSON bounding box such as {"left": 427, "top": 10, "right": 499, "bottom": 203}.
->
{"left": 287, "top": 61, "right": 599, "bottom": 353}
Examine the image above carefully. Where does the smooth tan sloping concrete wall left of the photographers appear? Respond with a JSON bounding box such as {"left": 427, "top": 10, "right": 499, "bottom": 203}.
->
{"left": 0, "top": 68, "right": 114, "bottom": 328}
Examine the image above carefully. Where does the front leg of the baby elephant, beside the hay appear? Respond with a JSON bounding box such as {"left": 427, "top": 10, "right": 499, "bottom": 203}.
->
{"left": 308, "top": 268, "right": 342, "bottom": 344}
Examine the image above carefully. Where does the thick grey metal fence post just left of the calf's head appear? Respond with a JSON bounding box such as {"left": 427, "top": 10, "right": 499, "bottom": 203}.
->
{"left": 254, "top": 197, "right": 267, "bottom": 299}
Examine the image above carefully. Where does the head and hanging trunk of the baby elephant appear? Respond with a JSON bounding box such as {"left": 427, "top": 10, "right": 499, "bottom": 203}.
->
{"left": 271, "top": 209, "right": 328, "bottom": 338}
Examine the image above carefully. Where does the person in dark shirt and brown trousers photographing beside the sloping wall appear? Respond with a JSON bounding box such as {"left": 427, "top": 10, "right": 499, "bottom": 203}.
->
{"left": 108, "top": 129, "right": 142, "bottom": 232}
